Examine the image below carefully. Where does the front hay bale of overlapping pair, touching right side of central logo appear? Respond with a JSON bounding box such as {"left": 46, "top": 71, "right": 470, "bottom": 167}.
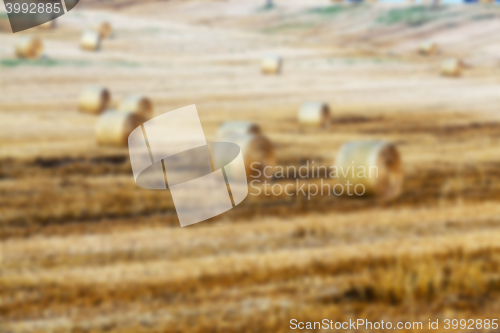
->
{"left": 217, "top": 134, "right": 276, "bottom": 182}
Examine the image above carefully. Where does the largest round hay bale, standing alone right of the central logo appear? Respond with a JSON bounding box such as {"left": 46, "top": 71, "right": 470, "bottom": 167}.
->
{"left": 335, "top": 141, "right": 403, "bottom": 200}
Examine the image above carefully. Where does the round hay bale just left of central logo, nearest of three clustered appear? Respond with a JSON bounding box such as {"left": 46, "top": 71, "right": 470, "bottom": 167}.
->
{"left": 95, "top": 110, "right": 140, "bottom": 147}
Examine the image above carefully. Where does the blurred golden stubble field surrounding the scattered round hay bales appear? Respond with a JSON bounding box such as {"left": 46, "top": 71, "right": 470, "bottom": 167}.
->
{"left": 0, "top": 0, "right": 500, "bottom": 332}
